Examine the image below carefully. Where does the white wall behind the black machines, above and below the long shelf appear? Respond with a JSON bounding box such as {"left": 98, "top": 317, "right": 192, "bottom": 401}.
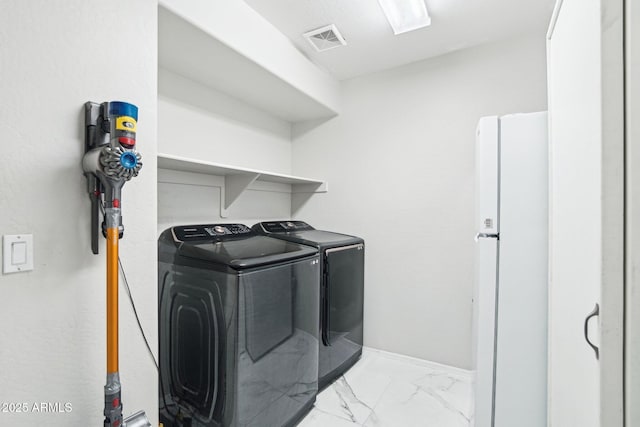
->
{"left": 158, "top": 69, "right": 291, "bottom": 233}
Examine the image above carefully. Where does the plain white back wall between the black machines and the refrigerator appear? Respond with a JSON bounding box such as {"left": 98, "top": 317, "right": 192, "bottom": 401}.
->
{"left": 293, "top": 34, "right": 546, "bottom": 368}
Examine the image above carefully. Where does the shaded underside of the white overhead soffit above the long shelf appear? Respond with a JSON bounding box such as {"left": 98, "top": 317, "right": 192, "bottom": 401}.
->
{"left": 158, "top": 1, "right": 339, "bottom": 123}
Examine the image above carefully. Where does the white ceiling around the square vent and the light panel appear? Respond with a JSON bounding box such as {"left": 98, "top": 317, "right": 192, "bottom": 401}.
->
{"left": 245, "top": 0, "right": 555, "bottom": 80}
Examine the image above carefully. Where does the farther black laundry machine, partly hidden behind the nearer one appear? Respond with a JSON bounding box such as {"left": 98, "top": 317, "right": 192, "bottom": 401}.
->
{"left": 253, "top": 221, "right": 364, "bottom": 389}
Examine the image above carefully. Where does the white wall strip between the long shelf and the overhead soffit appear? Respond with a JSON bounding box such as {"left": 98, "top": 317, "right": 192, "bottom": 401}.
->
{"left": 158, "top": 69, "right": 291, "bottom": 174}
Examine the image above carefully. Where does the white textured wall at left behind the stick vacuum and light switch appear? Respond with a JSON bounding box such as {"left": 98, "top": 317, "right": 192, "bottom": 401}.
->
{"left": 0, "top": 0, "right": 157, "bottom": 426}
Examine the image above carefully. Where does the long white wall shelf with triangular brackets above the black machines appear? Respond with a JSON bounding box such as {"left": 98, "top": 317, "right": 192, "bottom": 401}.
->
{"left": 158, "top": 153, "right": 328, "bottom": 217}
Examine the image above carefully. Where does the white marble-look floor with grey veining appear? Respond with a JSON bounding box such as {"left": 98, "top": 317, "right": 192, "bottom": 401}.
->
{"left": 298, "top": 348, "right": 473, "bottom": 427}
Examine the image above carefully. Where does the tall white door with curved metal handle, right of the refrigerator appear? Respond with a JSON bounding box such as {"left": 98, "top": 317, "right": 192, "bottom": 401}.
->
{"left": 547, "top": 0, "right": 624, "bottom": 427}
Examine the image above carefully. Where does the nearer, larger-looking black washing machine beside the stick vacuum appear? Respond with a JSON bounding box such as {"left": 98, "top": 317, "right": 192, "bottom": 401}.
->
{"left": 158, "top": 224, "right": 320, "bottom": 427}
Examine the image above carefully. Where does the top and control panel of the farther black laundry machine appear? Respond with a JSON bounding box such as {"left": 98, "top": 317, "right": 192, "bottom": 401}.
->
{"left": 253, "top": 221, "right": 364, "bottom": 247}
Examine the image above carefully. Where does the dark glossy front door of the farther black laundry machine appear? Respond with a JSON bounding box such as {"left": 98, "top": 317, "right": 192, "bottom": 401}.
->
{"left": 322, "top": 244, "right": 364, "bottom": 345}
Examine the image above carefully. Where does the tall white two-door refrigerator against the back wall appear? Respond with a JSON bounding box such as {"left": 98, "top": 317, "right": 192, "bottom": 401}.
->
{"left": 473, "top": 112, "right": 548, "bottom": 427}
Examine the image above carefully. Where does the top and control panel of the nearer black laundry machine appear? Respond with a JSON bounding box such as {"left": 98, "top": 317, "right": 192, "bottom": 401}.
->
{"left": 171, "top": 224, "right": 318, "bottom": 270}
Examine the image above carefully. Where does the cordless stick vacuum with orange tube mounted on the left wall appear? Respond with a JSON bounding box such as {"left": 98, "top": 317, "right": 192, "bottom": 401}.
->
{"left": 82, "top": 101, "right": 151, "bottom": 427}
